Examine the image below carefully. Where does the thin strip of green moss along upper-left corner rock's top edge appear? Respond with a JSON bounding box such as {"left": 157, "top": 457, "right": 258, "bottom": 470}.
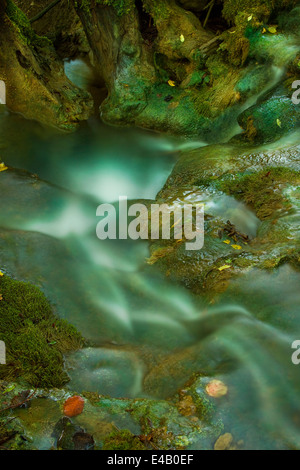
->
{"left": 6, "top": 0, "right": 52, "bottom": 47}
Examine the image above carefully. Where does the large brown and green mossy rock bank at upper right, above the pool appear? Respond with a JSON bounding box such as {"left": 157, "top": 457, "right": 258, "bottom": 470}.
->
{"left": 71, "top": 0, "right": 297, "bottom": 141}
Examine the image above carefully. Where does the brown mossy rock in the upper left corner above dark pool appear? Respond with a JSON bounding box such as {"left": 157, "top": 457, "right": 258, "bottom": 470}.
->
{"left": 0, "top": 0, "right": 92, "bottom": 130}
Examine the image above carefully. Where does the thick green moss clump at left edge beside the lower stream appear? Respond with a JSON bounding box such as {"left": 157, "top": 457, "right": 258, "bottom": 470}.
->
{"left": 0, "top": 276, "right": 83, "bottom": 387}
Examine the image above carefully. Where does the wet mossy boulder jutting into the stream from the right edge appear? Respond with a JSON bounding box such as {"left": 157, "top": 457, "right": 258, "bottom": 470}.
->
{"left": 149, "top": 133, "right": 300, "bottom": 296}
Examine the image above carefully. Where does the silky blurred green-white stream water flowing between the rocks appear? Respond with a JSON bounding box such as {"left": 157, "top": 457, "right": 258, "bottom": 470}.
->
{"left": 0, "top": 64, "right": 300, "bottom": 449}
